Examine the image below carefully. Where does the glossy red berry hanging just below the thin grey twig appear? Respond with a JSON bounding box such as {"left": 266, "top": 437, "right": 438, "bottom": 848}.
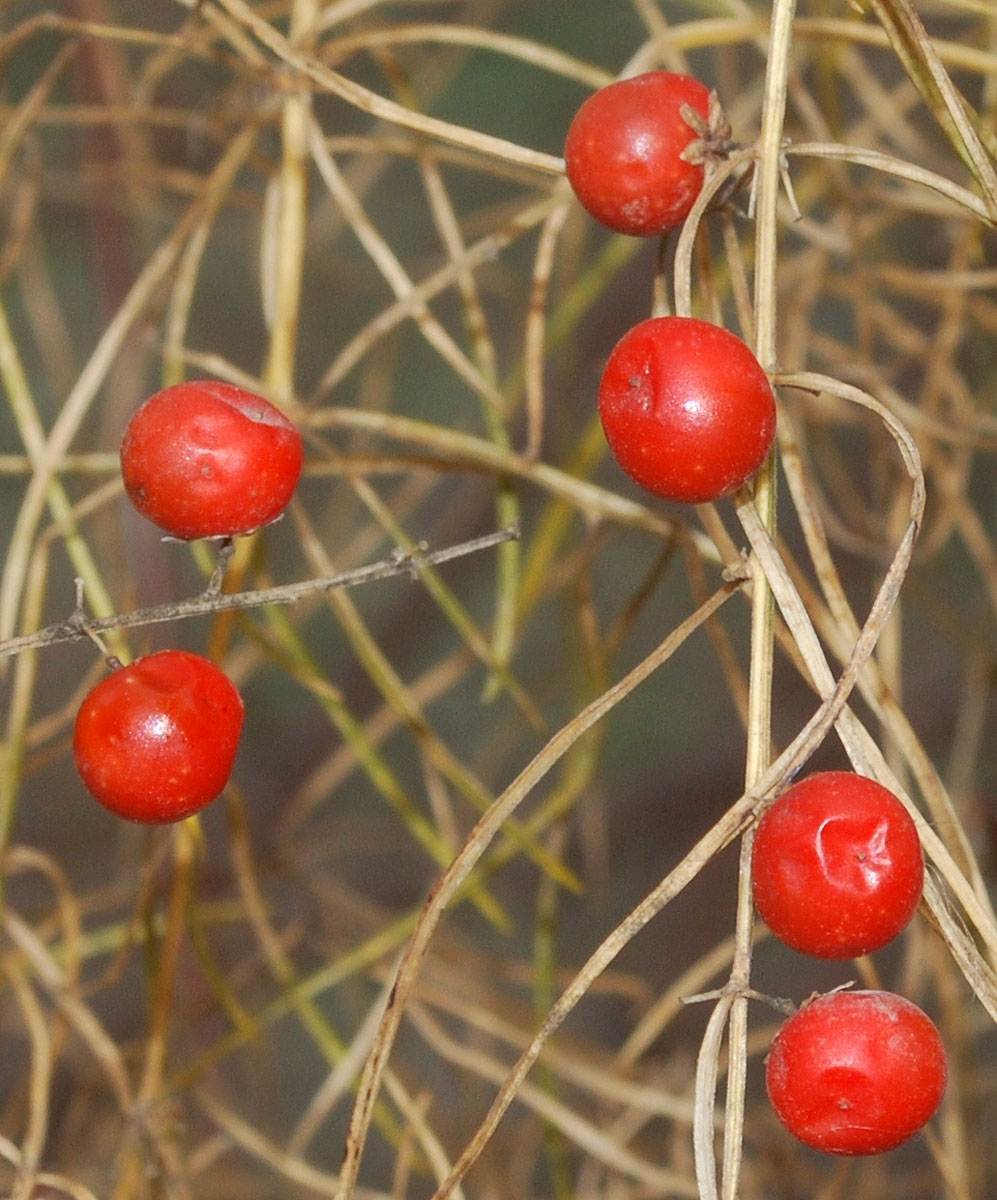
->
{"left": 73, "top": 650, "right": 244, "bottom": 823}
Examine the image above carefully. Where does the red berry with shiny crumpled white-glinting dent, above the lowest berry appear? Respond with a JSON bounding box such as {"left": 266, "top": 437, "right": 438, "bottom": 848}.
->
{"left": 751, "top": 770, "right": 924, "bottom": 959}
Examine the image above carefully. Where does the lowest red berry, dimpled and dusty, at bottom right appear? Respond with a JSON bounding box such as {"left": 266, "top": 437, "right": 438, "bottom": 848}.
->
{"left": 765, "top": 991, "right": 948, "bottom": 1154}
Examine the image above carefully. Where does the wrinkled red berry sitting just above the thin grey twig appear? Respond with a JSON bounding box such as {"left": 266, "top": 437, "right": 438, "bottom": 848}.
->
{"left": 121, "top": 379, "right": 304, "bottom": 539}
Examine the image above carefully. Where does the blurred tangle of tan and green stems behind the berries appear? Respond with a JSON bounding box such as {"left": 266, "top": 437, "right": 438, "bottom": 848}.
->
{"left": 0, "top": 0, "right": 997, "bottom": 1200}
